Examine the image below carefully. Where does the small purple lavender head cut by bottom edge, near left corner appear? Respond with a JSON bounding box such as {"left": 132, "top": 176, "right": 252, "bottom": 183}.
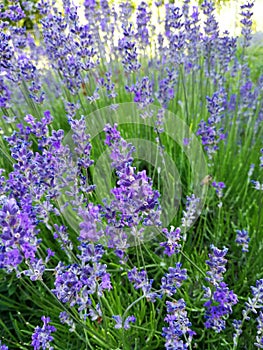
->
{"left": 31, "top": 316, "right": 56, "bottom": 350}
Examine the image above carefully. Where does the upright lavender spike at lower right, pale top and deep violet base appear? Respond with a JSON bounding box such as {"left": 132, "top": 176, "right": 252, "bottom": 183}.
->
{"left": 203, "top": 245, "right": 238, "bottom": 333}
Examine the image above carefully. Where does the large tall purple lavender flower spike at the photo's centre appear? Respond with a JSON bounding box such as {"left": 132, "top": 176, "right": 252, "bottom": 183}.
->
{"left": 103, "top": 124, "right": 161, "bottom": 259}
